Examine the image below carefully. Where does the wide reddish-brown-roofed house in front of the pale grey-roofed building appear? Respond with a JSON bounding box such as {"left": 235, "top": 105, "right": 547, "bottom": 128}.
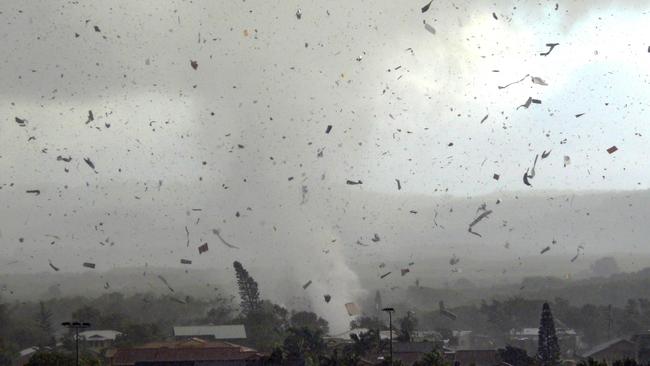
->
{"left": 108, "top": 338, "right": 268, "bottom": 366}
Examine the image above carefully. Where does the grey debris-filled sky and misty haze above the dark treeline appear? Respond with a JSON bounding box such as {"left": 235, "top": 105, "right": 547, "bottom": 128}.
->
{"left": 0, "top": 0, "right": 650, "bottom": 360}
